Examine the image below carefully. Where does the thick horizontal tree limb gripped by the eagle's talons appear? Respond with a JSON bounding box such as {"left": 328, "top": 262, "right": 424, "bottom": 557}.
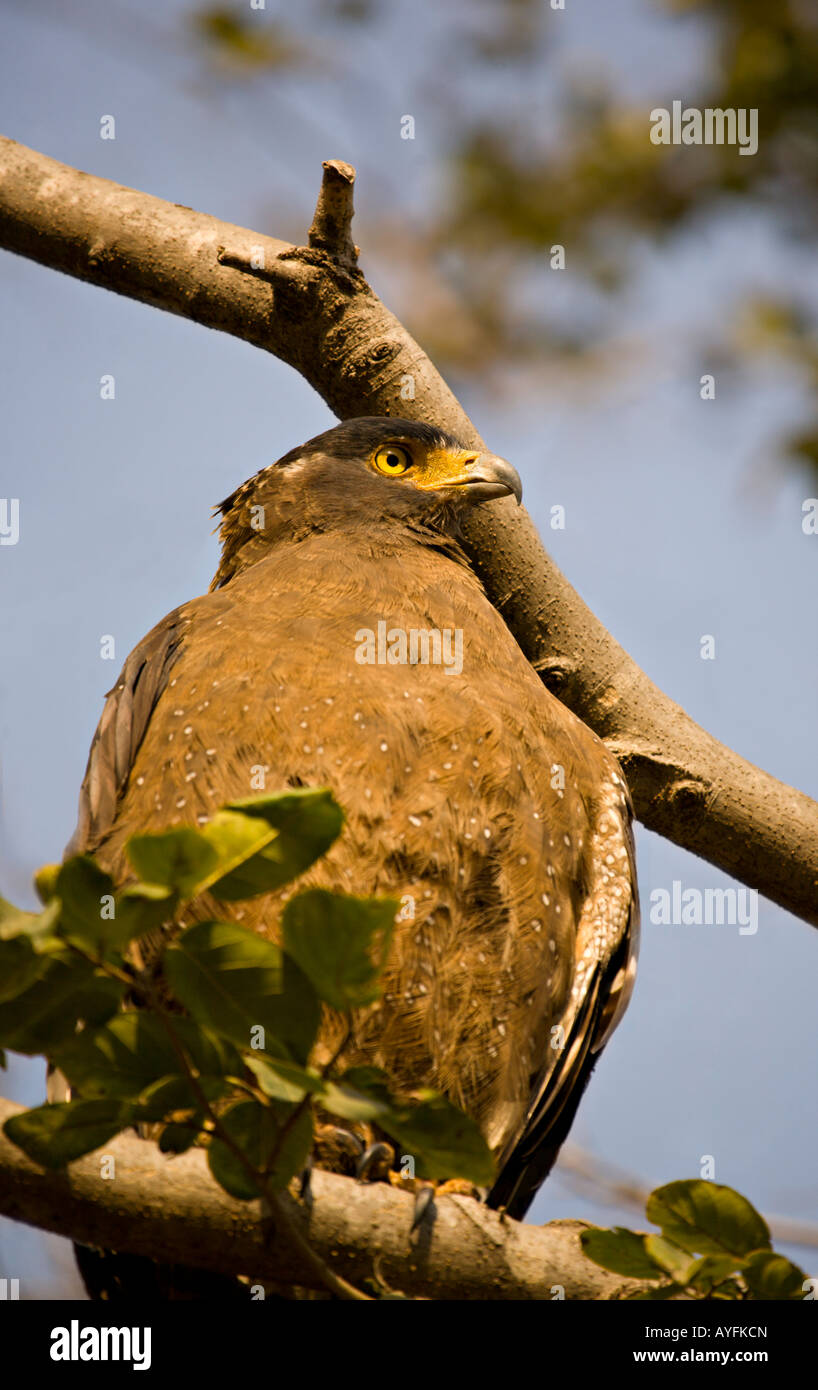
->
{"left": 0, "top": 1099, "right": 643, "bottom": 1300}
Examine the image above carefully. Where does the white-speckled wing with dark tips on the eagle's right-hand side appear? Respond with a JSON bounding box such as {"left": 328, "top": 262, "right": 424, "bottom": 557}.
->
{"left": 488, "top": 777, "right": 639, "bottom": 1220}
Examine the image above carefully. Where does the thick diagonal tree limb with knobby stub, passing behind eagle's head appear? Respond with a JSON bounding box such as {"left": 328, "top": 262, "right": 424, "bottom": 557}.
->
{"left": 0, "top": 139, "right": 818, "bottom": 926}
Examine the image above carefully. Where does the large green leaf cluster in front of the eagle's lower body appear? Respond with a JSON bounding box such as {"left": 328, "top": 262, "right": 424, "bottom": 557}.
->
{"left": 0, "top": 788, "right": 492, "bottom": 1200}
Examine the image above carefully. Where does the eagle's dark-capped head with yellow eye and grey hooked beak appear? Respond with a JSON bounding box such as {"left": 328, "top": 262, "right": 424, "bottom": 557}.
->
{"left": 213, "top": 416, "right": 522, "bottom": 588}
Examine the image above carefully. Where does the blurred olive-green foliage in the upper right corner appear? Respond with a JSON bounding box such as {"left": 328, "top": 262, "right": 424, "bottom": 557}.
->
{"left": 444, "top": 0, "right": 818, "bottom": 254}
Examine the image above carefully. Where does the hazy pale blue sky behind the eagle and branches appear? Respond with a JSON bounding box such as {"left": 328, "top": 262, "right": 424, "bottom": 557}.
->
{"left": 0, "top": 0, "right": 818, "bottom": 1297}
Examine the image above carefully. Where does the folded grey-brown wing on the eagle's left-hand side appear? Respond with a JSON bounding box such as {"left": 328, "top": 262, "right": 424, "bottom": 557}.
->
{"left": 65, "top": 607, "right": 189, "bottom": 855}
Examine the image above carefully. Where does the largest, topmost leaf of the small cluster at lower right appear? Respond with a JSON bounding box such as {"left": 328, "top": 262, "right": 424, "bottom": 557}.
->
{"left": 647, "top": 1177, "right": 769, "bottom": 1255}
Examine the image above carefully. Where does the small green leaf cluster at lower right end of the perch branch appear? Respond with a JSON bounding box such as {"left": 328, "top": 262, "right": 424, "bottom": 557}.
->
{"left": 580, "top": 1179, "right": 814, "bottom": 1301}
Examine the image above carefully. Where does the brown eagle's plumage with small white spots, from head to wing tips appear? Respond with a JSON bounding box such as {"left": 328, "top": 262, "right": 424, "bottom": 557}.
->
{"left": 72, "top": 418, "right": 637, "bottom": 1256}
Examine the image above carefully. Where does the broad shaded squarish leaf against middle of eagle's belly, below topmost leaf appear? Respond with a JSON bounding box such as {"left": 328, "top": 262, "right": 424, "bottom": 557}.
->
{"left": 282, "top": 888, "right": 398, "bottom": 1012}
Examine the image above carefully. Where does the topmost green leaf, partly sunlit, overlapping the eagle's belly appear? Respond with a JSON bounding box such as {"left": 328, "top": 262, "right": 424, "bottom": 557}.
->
{"left": 220, "top": 787, "right": 344, "bottom": 892}
